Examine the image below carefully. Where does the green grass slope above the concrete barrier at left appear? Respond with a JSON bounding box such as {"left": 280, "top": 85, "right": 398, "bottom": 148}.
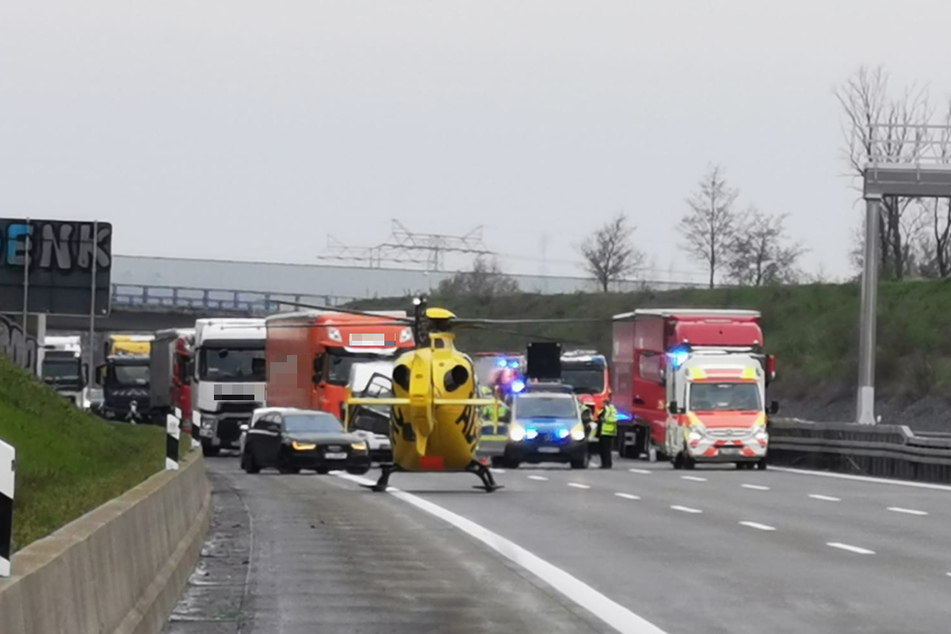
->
{"left": 0, "top": 354, "right": 171, "bottom": 550}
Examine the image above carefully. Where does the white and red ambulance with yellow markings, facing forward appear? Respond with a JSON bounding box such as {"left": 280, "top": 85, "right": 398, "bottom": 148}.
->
{"left": 666, "top": 350, "right": 778, "bottom": 469}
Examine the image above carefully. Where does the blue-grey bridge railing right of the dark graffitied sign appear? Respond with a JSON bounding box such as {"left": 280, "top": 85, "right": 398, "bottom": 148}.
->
{"left": 112, "top": 284, "right": 357, "bottom": 315}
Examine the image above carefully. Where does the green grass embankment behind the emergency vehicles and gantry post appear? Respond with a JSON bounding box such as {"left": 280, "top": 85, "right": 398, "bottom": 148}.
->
{"left": 355, "top": 280, "right": 951, "bottom": 420}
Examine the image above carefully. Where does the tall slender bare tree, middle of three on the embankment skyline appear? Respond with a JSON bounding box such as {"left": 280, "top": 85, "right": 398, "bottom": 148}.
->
{"left": 677, "top": 165, "right": 739, "bottom": 288}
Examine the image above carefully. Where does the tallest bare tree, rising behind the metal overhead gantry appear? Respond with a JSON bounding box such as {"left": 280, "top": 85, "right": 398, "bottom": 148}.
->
{"left": 836, "top": 66, "right": 933, "bottom": 279}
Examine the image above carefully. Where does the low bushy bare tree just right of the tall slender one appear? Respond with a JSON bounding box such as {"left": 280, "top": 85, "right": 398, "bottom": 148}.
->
{"left": 727, "top": 207, "right": 803, "bottom": 286}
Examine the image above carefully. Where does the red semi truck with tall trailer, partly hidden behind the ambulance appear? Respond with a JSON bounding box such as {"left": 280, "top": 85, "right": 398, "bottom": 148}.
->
{"left": 612, "top": 308, "right": 776, "bottom": 459}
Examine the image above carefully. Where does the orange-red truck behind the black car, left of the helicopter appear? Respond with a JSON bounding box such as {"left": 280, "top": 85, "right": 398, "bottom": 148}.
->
{"left": 265, "top": 311, "right": 415, "bottom": 420}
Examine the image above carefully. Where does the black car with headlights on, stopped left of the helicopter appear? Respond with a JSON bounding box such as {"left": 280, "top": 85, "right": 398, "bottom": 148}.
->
{"left": 241, "top": 410, "right": 370, "bottom": 475}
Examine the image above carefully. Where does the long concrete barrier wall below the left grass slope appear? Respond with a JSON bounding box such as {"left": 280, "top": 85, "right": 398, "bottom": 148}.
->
{"left": 0, "top": 451, "right": 211, "bottom": 634}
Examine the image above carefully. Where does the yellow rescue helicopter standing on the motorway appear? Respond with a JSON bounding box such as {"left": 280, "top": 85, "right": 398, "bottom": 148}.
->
{"left": 278, "top": 297, "right": 603, "bottom": 492}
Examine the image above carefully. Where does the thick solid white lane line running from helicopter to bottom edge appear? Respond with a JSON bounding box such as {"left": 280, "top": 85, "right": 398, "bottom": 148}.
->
{"left": 338, "top": 473, "right": 667, "bottom": 634}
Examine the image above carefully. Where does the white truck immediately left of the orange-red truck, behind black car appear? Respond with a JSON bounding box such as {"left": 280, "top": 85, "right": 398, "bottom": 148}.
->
{"left": 192, "top": 318, "right": 267, "bottom": 455}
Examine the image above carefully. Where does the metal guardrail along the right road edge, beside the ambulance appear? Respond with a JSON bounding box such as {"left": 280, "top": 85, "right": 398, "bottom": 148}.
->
{"left": 769, "top": 421, "right": 951, "bottom": 483}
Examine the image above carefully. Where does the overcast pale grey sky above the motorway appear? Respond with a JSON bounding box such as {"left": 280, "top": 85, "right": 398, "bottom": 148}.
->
{"left": 0, "top": 0, "right": 951, "bottom": 280}
